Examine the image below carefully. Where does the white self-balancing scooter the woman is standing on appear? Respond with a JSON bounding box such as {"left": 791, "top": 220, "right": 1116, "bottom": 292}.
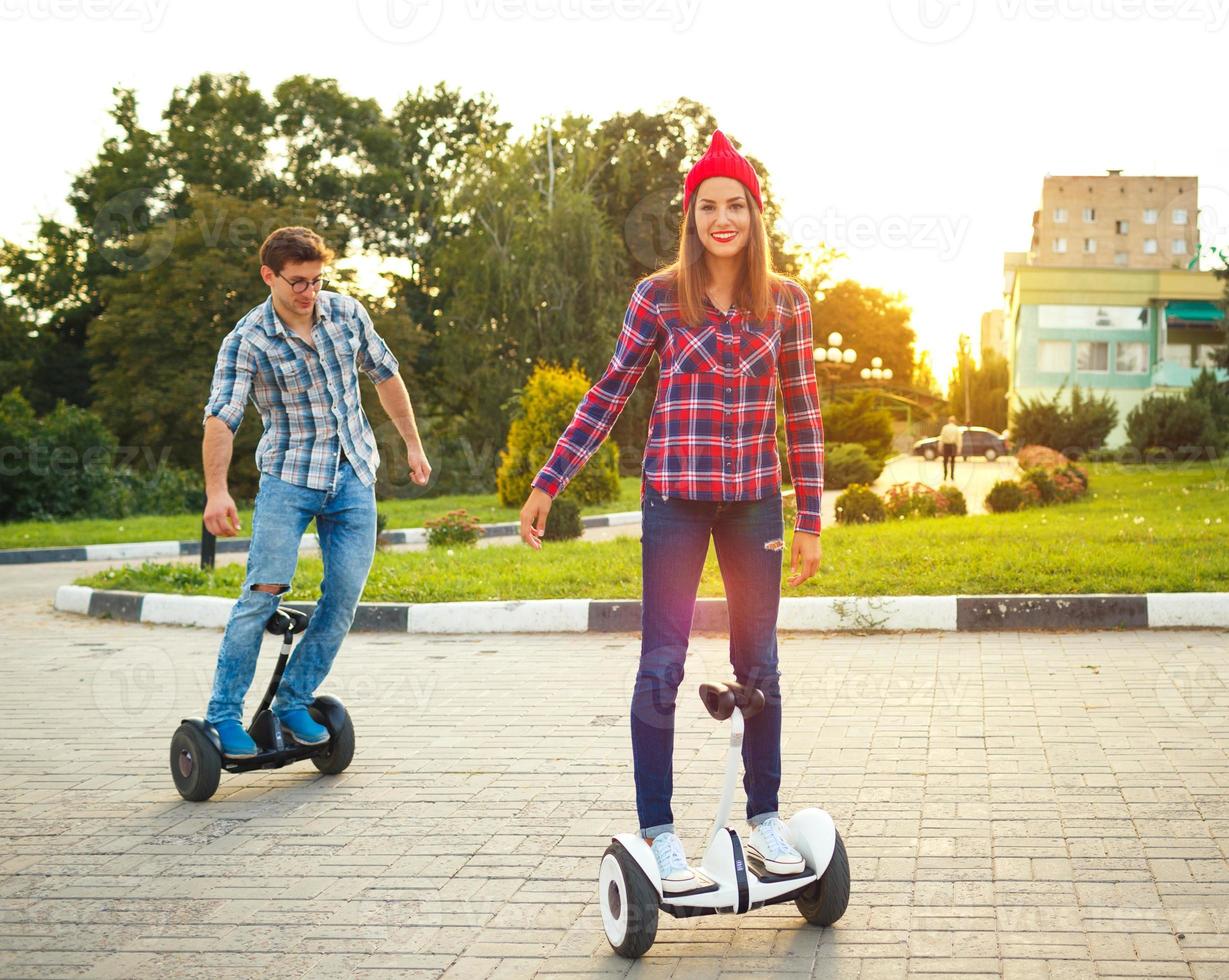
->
{"left": 597, "top": 682, "right": 849, "bottom": 959}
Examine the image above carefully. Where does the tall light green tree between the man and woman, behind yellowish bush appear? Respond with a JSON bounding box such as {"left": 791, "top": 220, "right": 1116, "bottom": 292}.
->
{"left": 426, "top": 128, "right": 629, "bottom": 467}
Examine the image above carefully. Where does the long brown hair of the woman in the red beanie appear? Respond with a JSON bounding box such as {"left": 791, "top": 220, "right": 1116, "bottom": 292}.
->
{"left": 645, "top": 188, "right": 782, "bottom": 327}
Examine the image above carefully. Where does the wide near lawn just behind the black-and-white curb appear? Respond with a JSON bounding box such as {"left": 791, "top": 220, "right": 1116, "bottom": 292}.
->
{"left": 79, "top": 464, "right": 1229, "bottom": 603}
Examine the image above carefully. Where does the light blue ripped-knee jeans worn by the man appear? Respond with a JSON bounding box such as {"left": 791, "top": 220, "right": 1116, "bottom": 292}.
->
{"left": 205, "top": 460, "right": 376, "bottom": 723}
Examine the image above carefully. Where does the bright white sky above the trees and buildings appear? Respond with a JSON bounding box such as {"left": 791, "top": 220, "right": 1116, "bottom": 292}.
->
{"left": 0, "top": 0, "right": 1229, "bottom": 385}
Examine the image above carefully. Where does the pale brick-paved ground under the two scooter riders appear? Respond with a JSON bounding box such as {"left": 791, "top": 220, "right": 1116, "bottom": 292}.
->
{"left": 0, "top": 566, "right": 1229, "bottom": 980}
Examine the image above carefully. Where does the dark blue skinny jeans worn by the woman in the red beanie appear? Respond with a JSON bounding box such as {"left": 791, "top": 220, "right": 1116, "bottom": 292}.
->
{"left": 632, "top": 486, "right": 783, "bottom": 837}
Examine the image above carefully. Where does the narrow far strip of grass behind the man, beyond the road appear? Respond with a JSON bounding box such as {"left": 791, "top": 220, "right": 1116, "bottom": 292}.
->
{"left": 0, "top": 477, "right": 640, "bottom": 548}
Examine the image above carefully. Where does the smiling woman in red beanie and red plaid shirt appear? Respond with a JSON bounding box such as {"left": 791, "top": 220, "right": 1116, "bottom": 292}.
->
{"left": 521, "top": 132, "right": 823, "bottom": 894}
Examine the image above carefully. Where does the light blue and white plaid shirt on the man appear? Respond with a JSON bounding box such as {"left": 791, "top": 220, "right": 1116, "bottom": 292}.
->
{"left": 205, "top": 291, "right": 397, "bottom": 491}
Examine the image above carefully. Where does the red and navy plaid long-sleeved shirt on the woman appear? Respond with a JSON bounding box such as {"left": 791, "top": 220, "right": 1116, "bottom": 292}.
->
{"left": 533, "top": 279, "right": 823, "bottom": 534}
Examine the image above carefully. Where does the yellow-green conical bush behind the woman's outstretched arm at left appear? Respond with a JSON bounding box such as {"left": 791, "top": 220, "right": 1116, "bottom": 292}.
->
{"left": 495, "top": 364, "right": 618, "bottom": 507}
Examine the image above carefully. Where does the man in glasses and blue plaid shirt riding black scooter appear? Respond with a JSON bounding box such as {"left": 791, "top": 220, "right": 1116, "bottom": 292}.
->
{"left": 203, "top": 227, "right": 431, "bottom": 759}
